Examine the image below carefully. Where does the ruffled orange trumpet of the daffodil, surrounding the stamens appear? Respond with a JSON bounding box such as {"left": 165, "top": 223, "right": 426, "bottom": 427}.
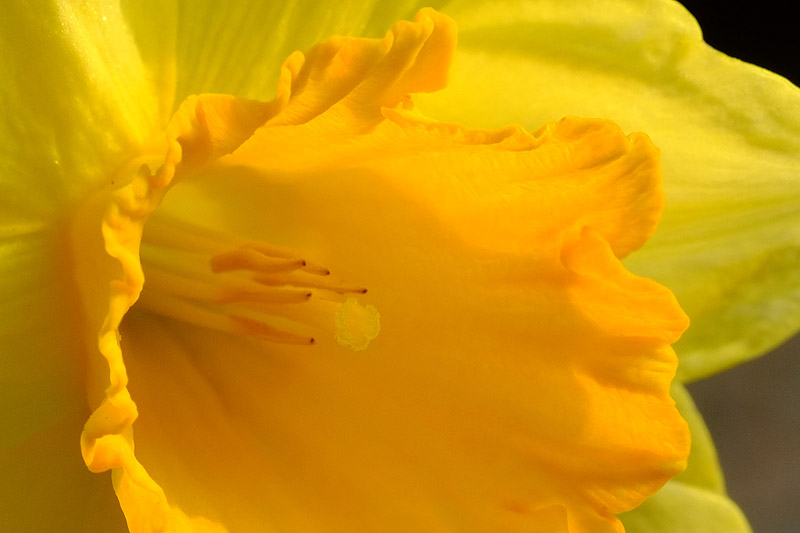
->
{"left": 101, "top": 11, "right": 688, "bottom": 533}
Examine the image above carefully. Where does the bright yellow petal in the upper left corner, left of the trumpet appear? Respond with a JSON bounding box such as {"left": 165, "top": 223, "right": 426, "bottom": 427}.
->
{"left": 0, "top": 1, "right": 166, "bottom": 218}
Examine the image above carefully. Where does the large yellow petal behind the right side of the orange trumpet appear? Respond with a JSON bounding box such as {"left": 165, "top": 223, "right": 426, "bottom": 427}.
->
{"left": 419, "top": 0, "right": 800, "bottom": 380}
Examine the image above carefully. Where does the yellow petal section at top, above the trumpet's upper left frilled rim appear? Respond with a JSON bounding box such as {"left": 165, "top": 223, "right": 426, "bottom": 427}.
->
{"left": 169, "top": 0, "right": 434, "bottom": 101}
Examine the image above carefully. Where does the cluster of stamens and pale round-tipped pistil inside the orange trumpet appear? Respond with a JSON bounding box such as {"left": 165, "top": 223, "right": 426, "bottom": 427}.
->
{"left": 137, "top": 213, "right": 380, "bottom": 350}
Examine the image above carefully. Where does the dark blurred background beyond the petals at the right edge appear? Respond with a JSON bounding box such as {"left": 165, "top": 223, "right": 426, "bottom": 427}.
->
{"left": 676, "top": 0, "right": 800, "bottom": 533}
